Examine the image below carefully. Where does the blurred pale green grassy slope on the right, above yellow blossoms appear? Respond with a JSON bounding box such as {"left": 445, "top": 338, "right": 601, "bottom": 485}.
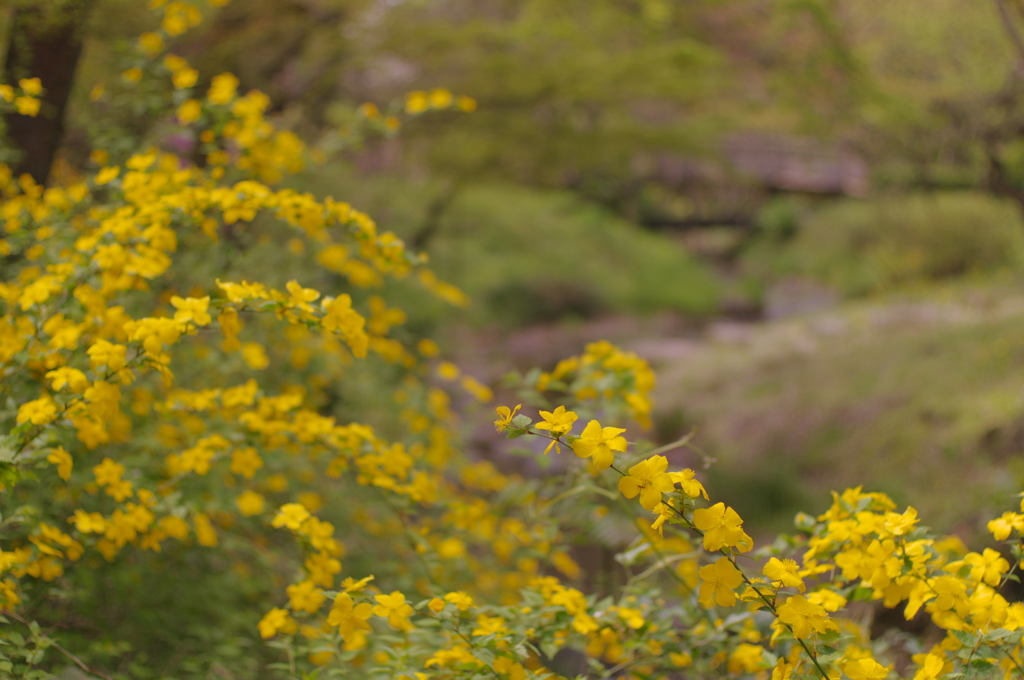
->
{"left": 657, "top": 281, "right": 1024, "bottom": 530}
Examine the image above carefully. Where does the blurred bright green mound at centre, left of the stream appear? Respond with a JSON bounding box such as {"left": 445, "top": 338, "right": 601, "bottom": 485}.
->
{"left": 299, "top": 170, "right": 721, "bottom": 328}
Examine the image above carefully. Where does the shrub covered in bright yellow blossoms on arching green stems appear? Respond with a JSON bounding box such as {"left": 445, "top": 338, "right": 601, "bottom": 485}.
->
{"left": 0, "top": 2, "right": 1024, "bottom": 680}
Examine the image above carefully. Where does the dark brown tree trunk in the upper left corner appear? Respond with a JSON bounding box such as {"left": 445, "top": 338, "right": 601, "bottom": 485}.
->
{"left": 3, "top": 0, "right": 95, "bottom": 184}
